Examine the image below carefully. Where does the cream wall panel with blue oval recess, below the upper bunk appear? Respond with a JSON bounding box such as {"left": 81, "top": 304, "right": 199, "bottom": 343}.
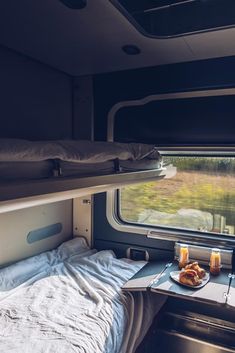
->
{"left": 0, "top": 200, "right": 72, "bottom": 266}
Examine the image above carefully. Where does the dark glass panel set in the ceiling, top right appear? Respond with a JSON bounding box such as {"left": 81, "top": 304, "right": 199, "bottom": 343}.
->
{"left": 111, "top": 0, "right": 235, "bottom": 37}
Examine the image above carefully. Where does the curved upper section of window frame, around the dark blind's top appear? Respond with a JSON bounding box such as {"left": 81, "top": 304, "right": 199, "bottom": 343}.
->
{"left": 107, "top": 88, "right": 235, "bottom": 142}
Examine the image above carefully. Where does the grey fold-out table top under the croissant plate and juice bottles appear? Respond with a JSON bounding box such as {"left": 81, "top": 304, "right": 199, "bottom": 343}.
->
{"left": 122, "top": 261, "right": 235, "bottom": 307}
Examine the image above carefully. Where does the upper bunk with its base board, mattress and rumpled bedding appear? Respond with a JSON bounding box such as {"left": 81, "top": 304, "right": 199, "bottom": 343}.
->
{"left": 0, "top": 139, "right": 174, "bottom": 212}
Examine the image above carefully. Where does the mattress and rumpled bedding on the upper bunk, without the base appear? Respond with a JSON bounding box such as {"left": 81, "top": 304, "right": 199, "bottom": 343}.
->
{"left": 0, "top": 139, "right": 161, "bottom": 179}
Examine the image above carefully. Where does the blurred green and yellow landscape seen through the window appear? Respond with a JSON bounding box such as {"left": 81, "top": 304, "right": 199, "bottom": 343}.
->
{"left": 119, "top": 156, "right": 235, "bottom": 237}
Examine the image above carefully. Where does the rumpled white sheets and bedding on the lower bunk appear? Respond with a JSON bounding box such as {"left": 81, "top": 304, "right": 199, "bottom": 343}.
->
{"left": 0, "top": 238, "right": 165, "bottom": 353}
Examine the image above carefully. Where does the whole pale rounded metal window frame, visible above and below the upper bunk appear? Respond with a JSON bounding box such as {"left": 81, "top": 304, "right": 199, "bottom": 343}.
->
{"left": 106, "top": 87, "right": 235, "bottom": 248}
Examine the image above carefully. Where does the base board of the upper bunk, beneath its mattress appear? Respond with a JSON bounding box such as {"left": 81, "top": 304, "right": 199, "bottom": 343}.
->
{"left": 0, "top": 168, "right": 167, "bottom": 213}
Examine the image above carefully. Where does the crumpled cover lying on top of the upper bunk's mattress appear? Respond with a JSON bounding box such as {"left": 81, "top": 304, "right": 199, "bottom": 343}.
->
{"left": 0, "top": 139, "right": 161, "bottom": 163}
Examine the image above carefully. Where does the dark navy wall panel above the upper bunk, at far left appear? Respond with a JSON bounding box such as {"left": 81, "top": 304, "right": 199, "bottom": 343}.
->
{"left": 0, "top": 47, "right": 72, "bottom": 140}
